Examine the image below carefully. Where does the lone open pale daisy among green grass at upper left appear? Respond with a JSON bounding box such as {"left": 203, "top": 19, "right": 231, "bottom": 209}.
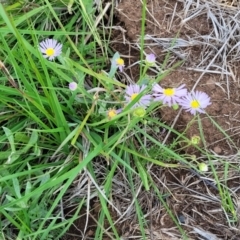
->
{"left": 39, "top": 38, "right": 62, "bottom": 61}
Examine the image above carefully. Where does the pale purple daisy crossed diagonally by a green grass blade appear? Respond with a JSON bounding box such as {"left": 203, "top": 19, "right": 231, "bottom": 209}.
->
{"left": 125, "top": 84, "right": 152, "bottom": 108}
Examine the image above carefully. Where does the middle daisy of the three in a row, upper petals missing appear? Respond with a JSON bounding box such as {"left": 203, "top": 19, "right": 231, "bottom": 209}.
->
{"left": 152, "top": 84, "right": 187, "bottom": 107}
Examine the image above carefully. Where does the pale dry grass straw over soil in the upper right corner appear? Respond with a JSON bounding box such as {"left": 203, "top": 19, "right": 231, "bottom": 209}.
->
{"left": 145, "top": 0, "right": 240, "bottom": 88}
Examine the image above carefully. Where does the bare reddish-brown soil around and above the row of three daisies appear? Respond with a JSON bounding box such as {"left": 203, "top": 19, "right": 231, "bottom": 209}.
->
{"left": 113, "top": 0, "right": 240, "bottom": 155}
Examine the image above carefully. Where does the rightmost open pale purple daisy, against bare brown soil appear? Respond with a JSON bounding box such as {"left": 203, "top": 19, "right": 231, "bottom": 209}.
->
{"left": 179, "top": 91, "right": 211, "bottom": 115}
